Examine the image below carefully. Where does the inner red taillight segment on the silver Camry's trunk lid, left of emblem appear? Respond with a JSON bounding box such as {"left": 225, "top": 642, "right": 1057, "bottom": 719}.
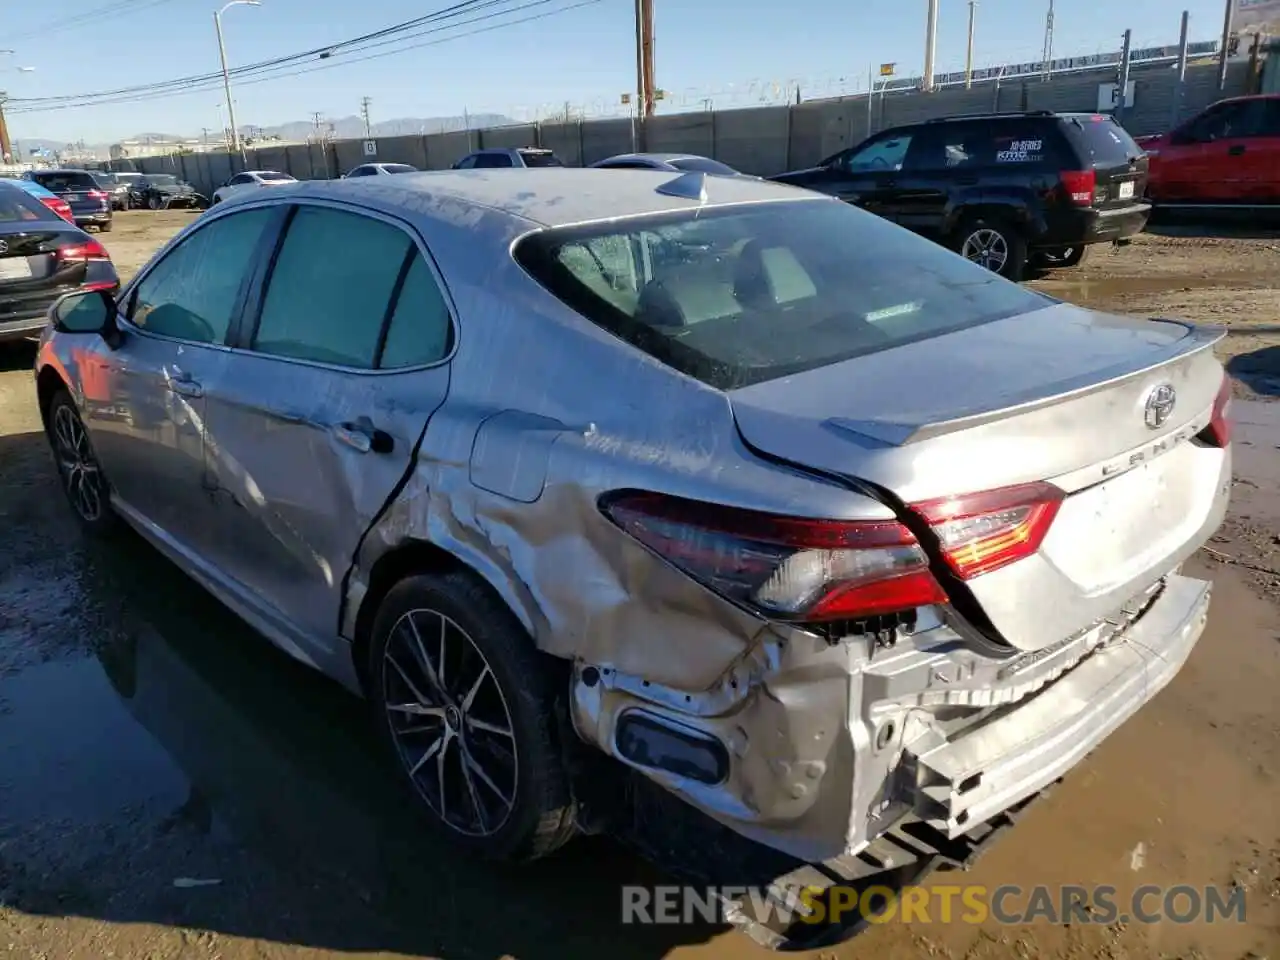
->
{"left": 911, "top": 483, "right": 1065, "bottom": 580}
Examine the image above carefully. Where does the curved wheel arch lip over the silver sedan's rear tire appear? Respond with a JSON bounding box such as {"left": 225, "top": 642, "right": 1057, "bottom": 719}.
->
{"left": 352, "top": 539, "right": 538, "bottom": 692}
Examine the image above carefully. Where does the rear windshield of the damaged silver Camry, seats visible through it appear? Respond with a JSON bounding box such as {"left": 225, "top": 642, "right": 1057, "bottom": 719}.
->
{"left": 516, "top": 200, "right": 1052, "bottom": 390}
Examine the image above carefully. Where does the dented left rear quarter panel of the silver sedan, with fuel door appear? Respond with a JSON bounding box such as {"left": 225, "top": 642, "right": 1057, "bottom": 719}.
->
{"left": 346, "top": 218, "right": 890, "bottom": 691}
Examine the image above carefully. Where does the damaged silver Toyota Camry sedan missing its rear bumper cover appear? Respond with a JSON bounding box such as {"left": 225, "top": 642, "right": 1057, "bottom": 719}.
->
{"left": 36, "top": 169, "right": 1231, "bottom": 942}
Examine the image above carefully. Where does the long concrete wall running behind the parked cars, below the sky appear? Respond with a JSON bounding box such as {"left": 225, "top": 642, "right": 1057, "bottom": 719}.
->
{"left": 102, "top": 61, "right": 1249, "bottom": 193}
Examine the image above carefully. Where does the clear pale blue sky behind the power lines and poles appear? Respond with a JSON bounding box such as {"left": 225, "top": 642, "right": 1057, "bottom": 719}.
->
{"left": 0, "top": 0, "right": 1224, "bottom": 142}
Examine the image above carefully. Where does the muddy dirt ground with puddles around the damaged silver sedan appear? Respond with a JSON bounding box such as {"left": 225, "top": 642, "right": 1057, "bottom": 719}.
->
{"left": 0, "top": 211, "right": 1280, "bottom": 960}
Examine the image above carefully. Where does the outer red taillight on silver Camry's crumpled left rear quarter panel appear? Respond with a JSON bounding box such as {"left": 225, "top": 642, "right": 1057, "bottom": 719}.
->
{"left": 600, "top": 492, "right": 947, "bottom": 622}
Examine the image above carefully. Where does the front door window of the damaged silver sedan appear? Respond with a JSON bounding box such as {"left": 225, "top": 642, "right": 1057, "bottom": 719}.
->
{"left": 129, "top": 209, "right": 274, "bottom": 343}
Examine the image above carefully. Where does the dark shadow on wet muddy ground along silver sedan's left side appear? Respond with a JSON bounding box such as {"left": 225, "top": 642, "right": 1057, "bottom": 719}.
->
{"left": 0, "top": 433, "right": 732, "bottom": 960}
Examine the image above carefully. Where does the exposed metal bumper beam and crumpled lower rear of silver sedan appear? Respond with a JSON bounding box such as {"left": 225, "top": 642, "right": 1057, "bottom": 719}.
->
{"left": 573, "top": 575, "right": 1210, "bottom": 863}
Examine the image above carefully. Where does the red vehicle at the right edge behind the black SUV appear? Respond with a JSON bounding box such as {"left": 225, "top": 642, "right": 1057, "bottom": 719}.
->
{"left": 1138, "top": 95, "right": 1280, "bottom": 205}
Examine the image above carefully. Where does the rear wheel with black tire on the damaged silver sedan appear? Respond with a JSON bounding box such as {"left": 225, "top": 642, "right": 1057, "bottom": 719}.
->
{"left": 366, "top": 571, "right": 576, "bottom": 860}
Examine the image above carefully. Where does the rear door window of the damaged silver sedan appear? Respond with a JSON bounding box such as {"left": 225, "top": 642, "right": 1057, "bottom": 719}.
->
{"left": 253, "top": 206, "right": 411, "bottom": 370}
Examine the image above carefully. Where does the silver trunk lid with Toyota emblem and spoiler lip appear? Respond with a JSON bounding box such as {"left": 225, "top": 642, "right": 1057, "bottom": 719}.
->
{"left": 728, "top": 303, "right": 1230, "bottom": 650}
